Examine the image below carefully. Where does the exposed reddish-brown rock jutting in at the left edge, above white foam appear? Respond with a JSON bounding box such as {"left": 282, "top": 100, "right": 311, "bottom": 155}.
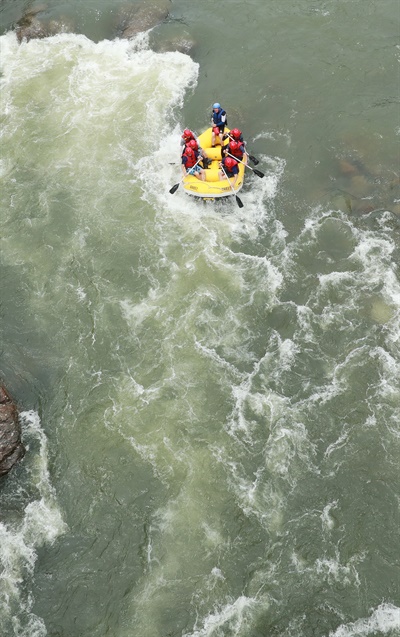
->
{"left": 0, "top": 385, "right": 25, "bottom": 476}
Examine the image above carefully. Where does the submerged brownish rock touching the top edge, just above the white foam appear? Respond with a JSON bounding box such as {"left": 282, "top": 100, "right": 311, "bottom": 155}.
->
{"left": 118, "top": 0, "right": 170, "bottom": 39}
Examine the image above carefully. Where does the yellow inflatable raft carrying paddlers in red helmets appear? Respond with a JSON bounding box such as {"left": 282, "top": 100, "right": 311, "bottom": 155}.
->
{"left": 183, "top": 128, "right": 245, "bottom": 199}
